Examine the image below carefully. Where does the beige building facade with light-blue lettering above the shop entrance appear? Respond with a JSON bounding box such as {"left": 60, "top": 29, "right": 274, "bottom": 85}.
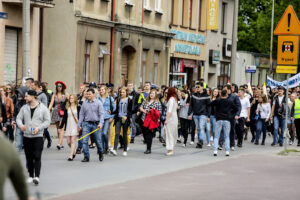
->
{"left": 169, "top": 0, "right": 207, "bottom": 87}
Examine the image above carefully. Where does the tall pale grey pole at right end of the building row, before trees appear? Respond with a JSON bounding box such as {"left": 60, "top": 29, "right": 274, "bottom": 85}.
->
{"left": 230, "top": 0, "right": 239, "bottom": 83}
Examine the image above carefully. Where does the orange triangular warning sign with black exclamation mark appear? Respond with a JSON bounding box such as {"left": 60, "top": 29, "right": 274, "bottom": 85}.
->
{"left": 274, "top": 5, "right": 300, "bottom": 35}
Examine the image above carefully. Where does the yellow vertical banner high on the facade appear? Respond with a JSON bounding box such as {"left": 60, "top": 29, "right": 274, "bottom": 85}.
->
{"left": 206, "top": 0, "right": 219, "bottom": 30}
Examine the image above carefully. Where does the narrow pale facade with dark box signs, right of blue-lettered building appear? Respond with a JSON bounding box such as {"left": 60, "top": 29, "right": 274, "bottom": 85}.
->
{"left": 204, "top": 0, "right": 234, "bottom": 87}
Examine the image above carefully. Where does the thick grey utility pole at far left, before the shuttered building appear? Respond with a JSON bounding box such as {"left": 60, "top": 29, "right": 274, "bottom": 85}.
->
{"left": 22, "top": 0, "right": 30, "bottom": 78}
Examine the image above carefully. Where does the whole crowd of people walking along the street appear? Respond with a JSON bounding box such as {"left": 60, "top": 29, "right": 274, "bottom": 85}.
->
{"left": 0, "top": 78, "right": 300, "bottom": 187}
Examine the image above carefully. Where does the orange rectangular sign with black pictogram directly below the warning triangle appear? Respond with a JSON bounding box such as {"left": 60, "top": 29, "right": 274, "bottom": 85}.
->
{"left": 277, "top": 35, "right": 299, "bottom": 65}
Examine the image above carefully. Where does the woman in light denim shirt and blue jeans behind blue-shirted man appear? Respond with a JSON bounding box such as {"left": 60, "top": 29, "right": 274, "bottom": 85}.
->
{"left": 99, "top": 85, "right": 116, "bottom": 154}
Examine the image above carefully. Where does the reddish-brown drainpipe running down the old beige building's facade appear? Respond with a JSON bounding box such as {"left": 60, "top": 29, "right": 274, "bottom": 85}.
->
{"left": 109, "top": 0, "right": 115, "bottom": 83}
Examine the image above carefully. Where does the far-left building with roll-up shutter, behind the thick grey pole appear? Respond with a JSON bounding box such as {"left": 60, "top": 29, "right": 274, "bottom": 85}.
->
{"left": 0, "top": 0, "right": 54, "bottom": 85}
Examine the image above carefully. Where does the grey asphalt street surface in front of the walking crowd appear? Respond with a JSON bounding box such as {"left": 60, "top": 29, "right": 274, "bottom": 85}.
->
{"left": 5, "top": 125, "right": 300, "bottom": 200}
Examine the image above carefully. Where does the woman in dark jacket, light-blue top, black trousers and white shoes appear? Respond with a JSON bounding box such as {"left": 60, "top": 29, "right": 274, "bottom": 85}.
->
{"left": 111, "top": 87, "right": 132, "bottom": 156}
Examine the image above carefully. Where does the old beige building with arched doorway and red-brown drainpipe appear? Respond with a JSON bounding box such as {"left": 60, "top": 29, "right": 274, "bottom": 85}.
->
{"left": 42, "top": 0, "right": 173, "bottom": 92}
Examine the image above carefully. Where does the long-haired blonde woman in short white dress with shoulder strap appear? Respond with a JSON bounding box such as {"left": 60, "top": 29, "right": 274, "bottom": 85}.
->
{"left": 60, "top": 95, "right": 79, "bottom": 161}
